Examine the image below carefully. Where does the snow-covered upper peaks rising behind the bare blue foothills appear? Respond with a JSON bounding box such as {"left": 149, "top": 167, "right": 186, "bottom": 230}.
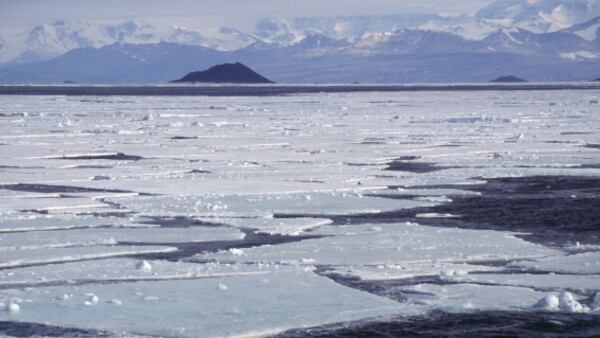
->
{"left": 0, "top": 0, "right": 600, "bottom": 62}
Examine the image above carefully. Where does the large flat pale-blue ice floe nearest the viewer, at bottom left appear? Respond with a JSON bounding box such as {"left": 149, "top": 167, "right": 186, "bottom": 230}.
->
{"left": 2, "top": 268, "right": 414, "bottom": 337}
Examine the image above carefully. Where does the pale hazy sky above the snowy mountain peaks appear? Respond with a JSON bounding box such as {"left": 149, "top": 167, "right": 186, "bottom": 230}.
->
{"left": 0, "top": 0, "right": 493, "bottom": 33}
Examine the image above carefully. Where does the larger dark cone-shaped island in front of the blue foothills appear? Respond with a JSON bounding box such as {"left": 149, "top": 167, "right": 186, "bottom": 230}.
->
{"left": 172, "top": 62, "right": 274, "bottom": 84}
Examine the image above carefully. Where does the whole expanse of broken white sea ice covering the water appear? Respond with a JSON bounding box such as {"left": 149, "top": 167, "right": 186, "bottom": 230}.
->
{"left": 0, "top": 90, "right": 600, "bottom": 337}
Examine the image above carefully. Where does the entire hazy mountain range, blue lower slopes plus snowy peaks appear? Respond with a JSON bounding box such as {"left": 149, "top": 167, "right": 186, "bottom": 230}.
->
{"left": 0, "top": 0, "right": 600, "bottom": 83}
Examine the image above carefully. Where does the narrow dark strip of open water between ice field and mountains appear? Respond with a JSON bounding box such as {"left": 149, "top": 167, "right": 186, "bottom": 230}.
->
{"left": 0, "top": 83, "right": 600, "bottom": 96}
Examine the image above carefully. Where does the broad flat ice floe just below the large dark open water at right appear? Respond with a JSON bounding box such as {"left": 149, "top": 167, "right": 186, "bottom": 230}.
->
{"left": 192, "top": 223, "right": 560, "bottom": 265}
